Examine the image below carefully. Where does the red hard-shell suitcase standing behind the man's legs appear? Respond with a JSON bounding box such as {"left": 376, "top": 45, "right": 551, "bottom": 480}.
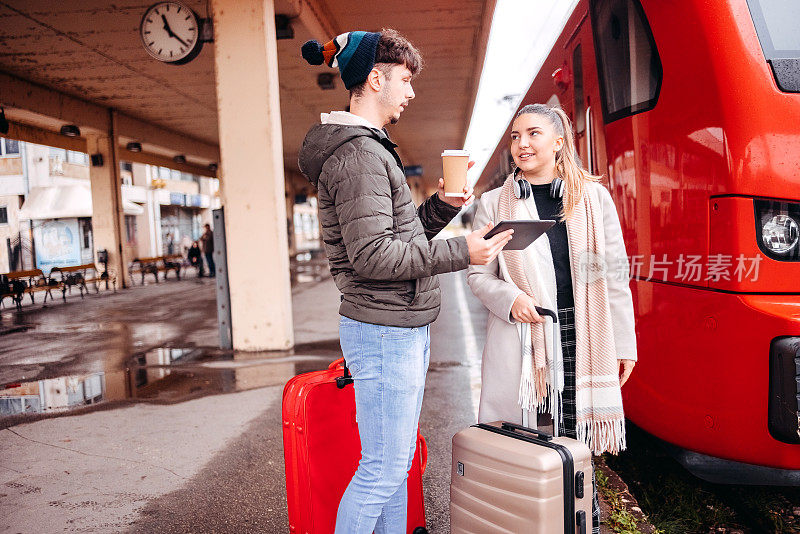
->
{"left": 283, "top": 359, "right": 428, "bottom": 534}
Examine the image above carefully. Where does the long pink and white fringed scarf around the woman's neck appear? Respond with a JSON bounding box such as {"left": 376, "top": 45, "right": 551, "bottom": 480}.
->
{"left": 498, "top": 176, "right": 625, "bottom": 454}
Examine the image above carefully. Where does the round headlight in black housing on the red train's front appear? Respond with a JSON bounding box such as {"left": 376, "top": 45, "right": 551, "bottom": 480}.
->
{"left": 755, "top": 200, "right": 800, "bottom": 261}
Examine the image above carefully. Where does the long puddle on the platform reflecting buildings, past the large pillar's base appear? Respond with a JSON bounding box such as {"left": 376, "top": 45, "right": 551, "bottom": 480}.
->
{"left": 0, "top": 347, "right": 339, "bottom": 428}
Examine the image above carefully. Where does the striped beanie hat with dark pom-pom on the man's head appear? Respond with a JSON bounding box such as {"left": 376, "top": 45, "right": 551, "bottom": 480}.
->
{"left": 301, "top": 31, "right": 381, "bottom": 90}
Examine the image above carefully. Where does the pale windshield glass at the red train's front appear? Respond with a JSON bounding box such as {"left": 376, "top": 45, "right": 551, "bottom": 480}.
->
{"left": 747, "top": 0, "right": 800, "bottom": 60}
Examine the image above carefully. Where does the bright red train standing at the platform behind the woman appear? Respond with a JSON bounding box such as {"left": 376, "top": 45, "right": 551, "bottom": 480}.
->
{"left": 476, "top": 0, "right": 800, "bottom": 485}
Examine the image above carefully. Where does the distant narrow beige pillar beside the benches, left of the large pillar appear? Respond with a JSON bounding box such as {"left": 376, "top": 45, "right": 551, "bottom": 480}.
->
{"left": 86, "top": 119, "right": 131, "bottom": 287}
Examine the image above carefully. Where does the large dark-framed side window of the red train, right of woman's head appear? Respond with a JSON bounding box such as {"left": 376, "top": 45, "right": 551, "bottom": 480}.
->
{"left": 591, "top": 0, "right": 663, "bottom": 122}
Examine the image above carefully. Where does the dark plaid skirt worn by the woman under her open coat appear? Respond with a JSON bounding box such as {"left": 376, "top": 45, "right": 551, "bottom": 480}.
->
{"left": 558, "top": 308, "right": 600, "bottom": 534}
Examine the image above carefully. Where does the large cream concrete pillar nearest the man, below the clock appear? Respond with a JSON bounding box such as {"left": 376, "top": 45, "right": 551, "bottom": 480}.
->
{"left": 213, "top": 0, "right": 294, "bottom": 350}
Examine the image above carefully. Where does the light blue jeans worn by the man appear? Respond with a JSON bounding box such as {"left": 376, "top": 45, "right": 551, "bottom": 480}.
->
{"left": 336, "top": 317, "right": 430, "bottom": 534}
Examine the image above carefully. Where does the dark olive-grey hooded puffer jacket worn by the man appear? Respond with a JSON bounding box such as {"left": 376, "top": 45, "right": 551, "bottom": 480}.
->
{"left": 299, "top": 124, "right": 469, "bottom": 327}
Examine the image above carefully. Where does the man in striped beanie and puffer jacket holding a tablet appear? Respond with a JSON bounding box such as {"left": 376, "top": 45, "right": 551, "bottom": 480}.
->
{"left": 299, "top": 30, "right": 511, "bottom": 534}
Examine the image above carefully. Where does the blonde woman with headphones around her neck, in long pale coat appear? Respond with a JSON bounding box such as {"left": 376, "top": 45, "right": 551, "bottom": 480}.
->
{"left": 467, "top": 104, "right": 636, "bottom": 532}
